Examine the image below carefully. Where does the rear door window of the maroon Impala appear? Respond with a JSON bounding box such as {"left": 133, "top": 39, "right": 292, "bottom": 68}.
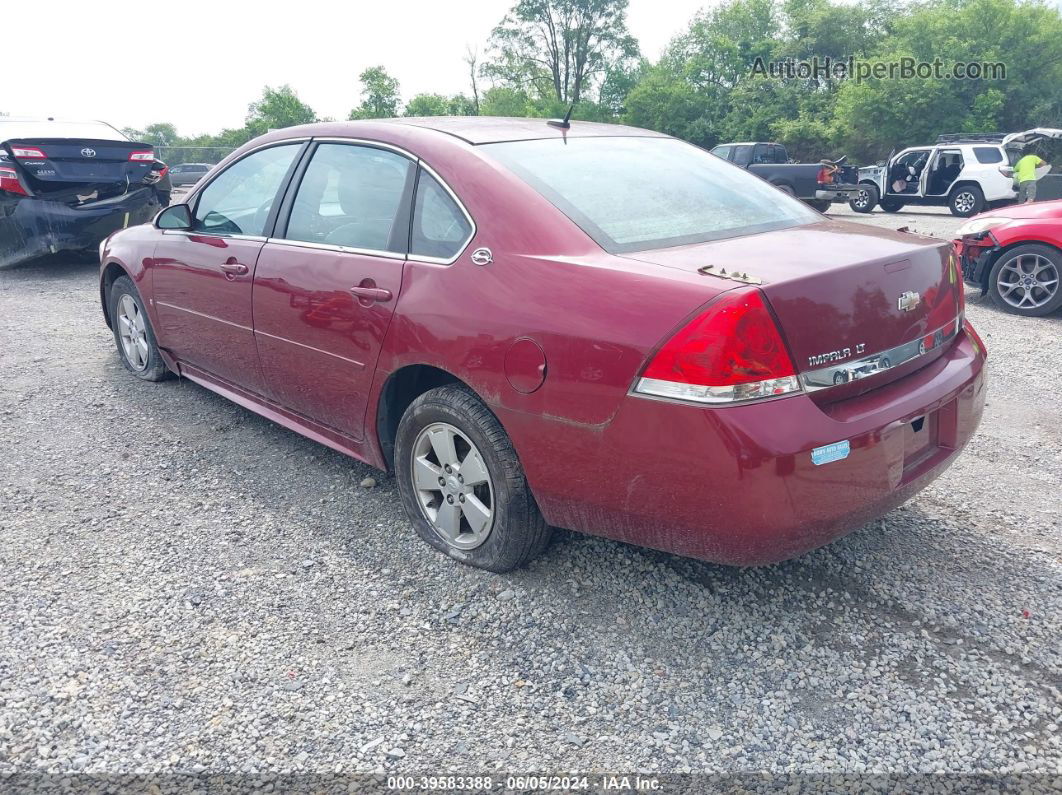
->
{"left": 284, "top": 143, "right": 414, "bottom": 254}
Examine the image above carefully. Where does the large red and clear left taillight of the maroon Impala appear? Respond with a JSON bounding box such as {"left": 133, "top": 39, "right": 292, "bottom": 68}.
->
{"left": 634, "top": 288, "right": 801, "bottom": 403}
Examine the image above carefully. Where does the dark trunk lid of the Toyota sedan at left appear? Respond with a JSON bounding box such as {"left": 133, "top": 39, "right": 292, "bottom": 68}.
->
{"left": 3, "top": 138, "right": 154, "bottom": 204}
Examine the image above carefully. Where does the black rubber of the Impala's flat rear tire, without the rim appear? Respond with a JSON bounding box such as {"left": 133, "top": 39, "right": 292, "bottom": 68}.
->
{"left": 394, "top": 384, "right": 552, "bottom": 573}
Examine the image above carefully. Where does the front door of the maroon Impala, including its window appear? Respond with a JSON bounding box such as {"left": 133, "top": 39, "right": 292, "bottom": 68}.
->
{"left": 151, "top": 141, "right": 306, "bottom": 393}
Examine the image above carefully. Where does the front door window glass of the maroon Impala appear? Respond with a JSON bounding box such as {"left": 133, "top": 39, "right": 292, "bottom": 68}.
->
{"left": 192, "top": 143, "right": 303, "bottom": 237}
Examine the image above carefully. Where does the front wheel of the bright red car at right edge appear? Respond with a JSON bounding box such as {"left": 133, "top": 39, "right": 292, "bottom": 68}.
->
{"left": 989, "top": 243, "right": 1062, "bottom": 317}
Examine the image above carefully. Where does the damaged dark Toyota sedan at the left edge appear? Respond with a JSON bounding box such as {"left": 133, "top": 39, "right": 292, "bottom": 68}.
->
{"left": 0, "top": 118, "right": 159, "bottom": 267}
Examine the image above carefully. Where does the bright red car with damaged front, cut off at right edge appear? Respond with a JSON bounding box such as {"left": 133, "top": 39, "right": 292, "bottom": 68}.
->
{"left": 955, "top": 200, "right": 1062, "bottom": 317}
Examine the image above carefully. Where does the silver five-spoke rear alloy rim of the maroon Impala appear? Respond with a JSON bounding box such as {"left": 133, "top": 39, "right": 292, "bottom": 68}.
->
{"left": 411, "top": 422, "right": 495, "bottom": 550}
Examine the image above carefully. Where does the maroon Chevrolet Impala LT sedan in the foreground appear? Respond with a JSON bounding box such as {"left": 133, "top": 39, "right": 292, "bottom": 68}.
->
{"left": 100, "top": 118, "right": 984, "bottom": 571}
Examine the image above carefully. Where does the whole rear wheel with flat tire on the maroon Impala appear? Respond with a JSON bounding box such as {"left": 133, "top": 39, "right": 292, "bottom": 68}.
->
{"left": 394, "top": 384, "right": 551, "bottom": 573}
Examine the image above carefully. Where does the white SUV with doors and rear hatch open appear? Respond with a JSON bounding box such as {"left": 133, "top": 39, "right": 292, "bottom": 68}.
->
{"left": 849, "top": 127, "right": 1062, "bottom": 218}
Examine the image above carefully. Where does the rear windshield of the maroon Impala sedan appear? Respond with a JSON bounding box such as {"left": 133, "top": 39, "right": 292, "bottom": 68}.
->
{"left": 482, "top": 137, "right": 821, "bottom": 254}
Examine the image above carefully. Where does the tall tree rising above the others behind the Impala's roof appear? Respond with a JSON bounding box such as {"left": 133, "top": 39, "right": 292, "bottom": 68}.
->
{"left": 483, "top": 0, "right": 638, "bottom": 105}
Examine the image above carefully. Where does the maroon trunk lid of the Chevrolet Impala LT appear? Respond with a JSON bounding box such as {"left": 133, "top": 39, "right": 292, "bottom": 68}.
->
{"left": 629, "top": 221, "right": 962, "bottom": 400}
